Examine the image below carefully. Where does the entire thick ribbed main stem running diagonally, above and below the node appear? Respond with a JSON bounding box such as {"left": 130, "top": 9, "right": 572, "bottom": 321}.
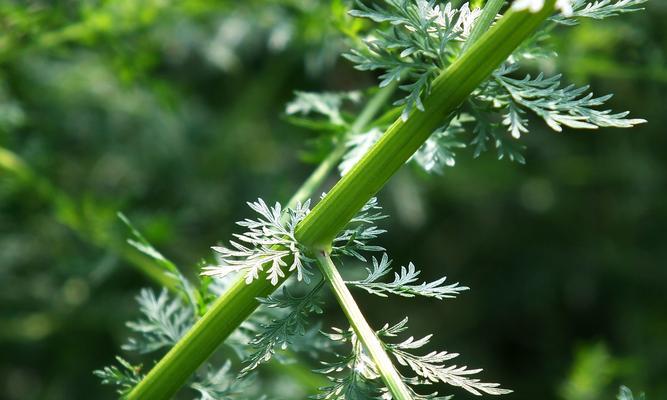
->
{"left": 128, "top": 0, "right": 555, "bottom": 400}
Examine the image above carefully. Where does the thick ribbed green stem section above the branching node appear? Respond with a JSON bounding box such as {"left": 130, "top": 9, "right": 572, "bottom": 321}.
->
{"left": 296, "top": 0, "right": 555, "bottom": 249}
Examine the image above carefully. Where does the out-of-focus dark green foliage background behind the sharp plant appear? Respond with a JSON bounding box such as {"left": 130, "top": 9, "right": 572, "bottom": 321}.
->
{"left": 0, "top": 0, "right": 667, "bottom": 400}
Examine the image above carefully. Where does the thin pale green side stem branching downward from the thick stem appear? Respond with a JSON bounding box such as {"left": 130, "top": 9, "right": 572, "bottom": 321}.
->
{"left": 317, "top": 251, "right": 412, "bottom": 400}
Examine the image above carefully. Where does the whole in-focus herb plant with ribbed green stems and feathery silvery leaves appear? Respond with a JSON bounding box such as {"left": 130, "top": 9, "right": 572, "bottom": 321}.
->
{"left": 96, "top": 0, "right": 644, "bottom": 400}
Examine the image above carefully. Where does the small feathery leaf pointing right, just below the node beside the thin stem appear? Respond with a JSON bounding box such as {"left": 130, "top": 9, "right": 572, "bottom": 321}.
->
{"left": 346, "top": 253, "right": 469, "bottom": 300}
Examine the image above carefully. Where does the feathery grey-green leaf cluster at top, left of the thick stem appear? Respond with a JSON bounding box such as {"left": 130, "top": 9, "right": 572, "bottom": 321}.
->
{"left": 345, "top": 0, "right": 480, "bottom": 120}
